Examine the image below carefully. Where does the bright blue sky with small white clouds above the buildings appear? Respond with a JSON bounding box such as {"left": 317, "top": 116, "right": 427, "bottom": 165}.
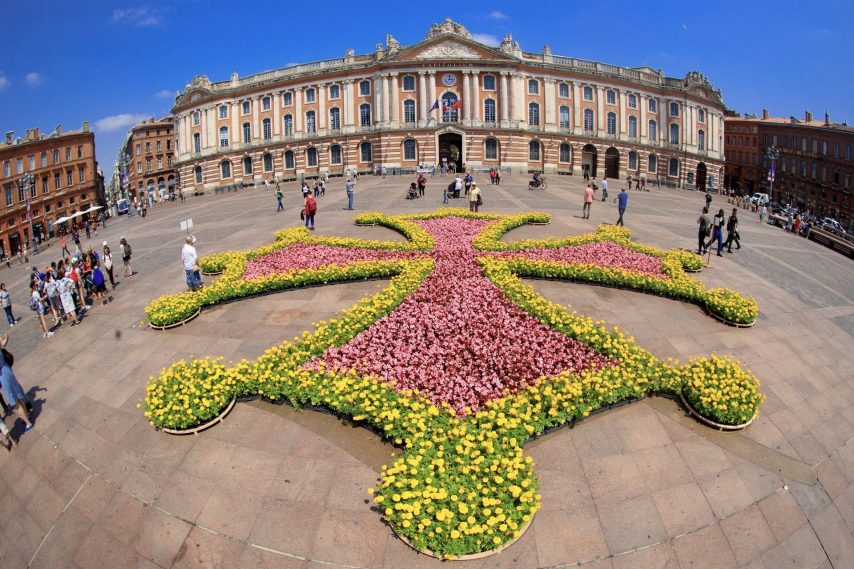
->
{"left": 0, "top": 0, "right": 854, "bottom": 180}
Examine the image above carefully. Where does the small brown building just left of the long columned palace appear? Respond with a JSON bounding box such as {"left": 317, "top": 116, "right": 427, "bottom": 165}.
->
{"left": 122, "top": 116, "right": 175, "bottom": 200}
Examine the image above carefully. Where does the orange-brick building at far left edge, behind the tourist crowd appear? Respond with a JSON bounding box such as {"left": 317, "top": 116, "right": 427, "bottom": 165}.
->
{"left": 0, "top": 122, "right": 104, "bottom": 255}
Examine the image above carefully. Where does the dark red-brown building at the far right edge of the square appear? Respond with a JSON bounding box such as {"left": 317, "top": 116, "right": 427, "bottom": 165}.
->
{"left": 724, "top": 111, "right": 854, "bottom": 231}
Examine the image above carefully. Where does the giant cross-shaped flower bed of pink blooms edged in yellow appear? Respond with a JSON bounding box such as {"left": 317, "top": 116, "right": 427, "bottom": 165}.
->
{"left": 145, "top": 210, "right": 763, "bottom": 557}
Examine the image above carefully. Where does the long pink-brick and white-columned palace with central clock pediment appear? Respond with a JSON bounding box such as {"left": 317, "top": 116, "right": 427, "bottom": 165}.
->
{"left": 172, "top": 19, "right": 724, "bottom": 193}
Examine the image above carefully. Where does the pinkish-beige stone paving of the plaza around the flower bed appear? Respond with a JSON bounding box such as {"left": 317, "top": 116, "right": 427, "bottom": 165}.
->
{"left": 0, "top": 175, "right": 854, "bottom": 569}
